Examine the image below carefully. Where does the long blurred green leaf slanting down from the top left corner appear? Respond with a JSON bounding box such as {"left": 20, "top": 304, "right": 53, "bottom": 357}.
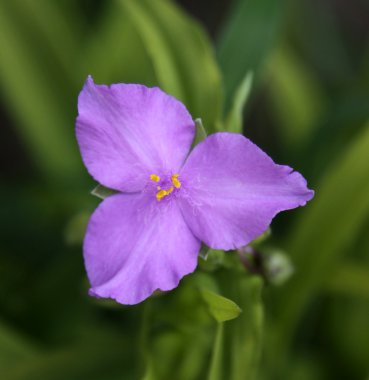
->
{"left": 0, "top": 2, "right": 82, "bottom": 183}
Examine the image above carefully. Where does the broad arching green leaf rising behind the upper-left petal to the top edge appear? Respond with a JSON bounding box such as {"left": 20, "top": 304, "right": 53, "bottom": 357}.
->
{"left": 144, "top": 0, "right": 223, "bottom": 131}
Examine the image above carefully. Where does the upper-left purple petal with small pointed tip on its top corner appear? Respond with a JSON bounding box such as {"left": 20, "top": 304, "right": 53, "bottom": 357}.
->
{"left": 76, "top": 77, "right": 195, "bottom": 192}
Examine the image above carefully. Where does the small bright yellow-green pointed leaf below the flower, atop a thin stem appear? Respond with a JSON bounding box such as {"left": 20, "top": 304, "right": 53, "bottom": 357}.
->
{"left": 200, "top": 289, "right": 242, "bottom": 322}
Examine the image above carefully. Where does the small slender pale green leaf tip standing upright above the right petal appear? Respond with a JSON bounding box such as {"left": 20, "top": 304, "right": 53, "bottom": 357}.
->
{"left": 225, "top": 72, "right": 253, "bottom": 133}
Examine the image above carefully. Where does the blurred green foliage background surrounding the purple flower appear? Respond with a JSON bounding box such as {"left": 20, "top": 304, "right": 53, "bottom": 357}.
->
{"left": 0, "top": 0, "right": 369, "bottom": 380}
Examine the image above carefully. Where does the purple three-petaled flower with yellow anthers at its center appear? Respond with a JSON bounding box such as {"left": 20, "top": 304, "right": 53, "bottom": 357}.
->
{"left": 77, "top": 77, "right": 313, "bottom": 304}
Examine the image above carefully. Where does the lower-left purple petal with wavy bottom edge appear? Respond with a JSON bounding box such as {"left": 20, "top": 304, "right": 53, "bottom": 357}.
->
{"left": 84, "top": 193, "right": 200, "bottom": 304}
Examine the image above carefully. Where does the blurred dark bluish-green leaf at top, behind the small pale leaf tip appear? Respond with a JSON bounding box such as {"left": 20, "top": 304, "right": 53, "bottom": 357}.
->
{"left": 217, "top": 0, "right": 285, "bottom": 110}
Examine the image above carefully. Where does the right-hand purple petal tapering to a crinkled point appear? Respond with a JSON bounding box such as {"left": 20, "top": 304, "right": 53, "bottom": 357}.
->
{"left": 180, "top": 133, "right": 314, "bottom": 250}
